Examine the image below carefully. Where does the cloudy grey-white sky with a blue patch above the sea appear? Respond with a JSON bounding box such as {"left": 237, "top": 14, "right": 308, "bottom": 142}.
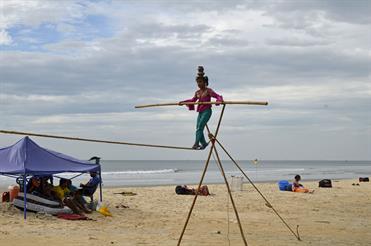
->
{"left": 0, "top": 0, "right": 371, "bottom": 160}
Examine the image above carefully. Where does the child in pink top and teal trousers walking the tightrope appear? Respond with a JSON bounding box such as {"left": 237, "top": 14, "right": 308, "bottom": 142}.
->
{"left": 179, "top": 66, "right": 223, "bottom": 149}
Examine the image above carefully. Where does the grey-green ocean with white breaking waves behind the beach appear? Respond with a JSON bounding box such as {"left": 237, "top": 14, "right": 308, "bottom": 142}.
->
{"left": 0, "top": 159, "right": 371, "bottom": 187}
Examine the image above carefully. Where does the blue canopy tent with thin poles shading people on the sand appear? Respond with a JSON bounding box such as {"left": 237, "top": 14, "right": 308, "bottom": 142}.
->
{"left": 0, "top": 137, "right": 102, "bottom": 219}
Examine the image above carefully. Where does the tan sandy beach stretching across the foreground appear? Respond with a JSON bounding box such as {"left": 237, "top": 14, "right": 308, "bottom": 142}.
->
{"left": 0, "top": 180, "right": 371, "bottom": 246}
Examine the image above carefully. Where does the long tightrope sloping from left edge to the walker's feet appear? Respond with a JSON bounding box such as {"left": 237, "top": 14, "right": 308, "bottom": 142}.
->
{"left": 0, "top": 130, "right": 194, "bottom": 150}
